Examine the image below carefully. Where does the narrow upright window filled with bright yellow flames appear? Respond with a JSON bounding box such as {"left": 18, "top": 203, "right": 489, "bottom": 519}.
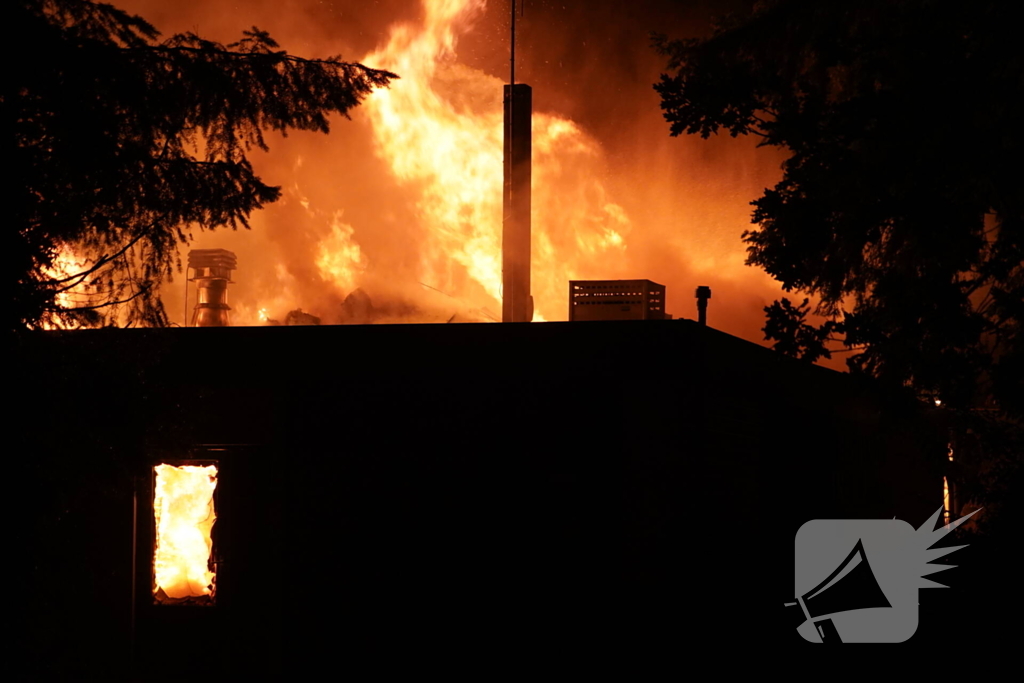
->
{"left": 153, "top": 464, "right": 217, "bottom": 604}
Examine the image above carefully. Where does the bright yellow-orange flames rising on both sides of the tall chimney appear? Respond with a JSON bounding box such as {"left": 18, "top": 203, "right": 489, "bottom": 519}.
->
{"left": 296, "top": 0, "right": 631, "bottom": 321}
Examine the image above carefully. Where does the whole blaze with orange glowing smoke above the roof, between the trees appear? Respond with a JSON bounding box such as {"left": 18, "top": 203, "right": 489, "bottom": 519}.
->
{"left": 142, "top": 0, "right": 790, "bottom": 344}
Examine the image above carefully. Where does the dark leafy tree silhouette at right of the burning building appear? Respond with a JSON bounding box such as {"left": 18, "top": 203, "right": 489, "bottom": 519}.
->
{"left": 654, "top": 0, "right": 1024, "bottom": 532}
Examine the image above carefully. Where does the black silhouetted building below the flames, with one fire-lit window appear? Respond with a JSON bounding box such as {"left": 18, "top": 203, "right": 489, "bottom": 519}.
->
{"left": 19, "top": 321, "right": 947, "bottom": 680}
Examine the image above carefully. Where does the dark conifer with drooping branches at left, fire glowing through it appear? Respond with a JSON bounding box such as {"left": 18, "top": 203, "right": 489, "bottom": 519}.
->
{"left": 12, "top": 0, "right": 397, "bottom": 330}
